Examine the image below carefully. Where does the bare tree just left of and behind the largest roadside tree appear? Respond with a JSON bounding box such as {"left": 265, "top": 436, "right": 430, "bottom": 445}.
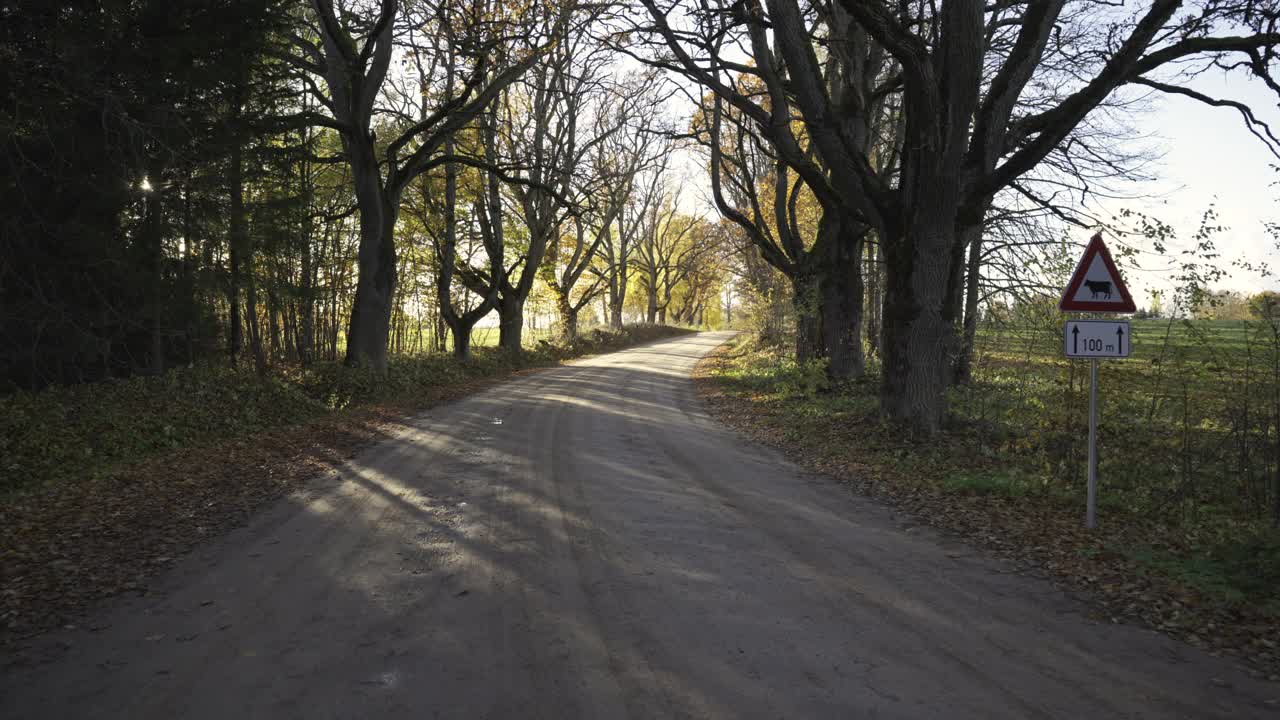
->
{"left": 635, "top": 0, "right": 890, "bottom": 377}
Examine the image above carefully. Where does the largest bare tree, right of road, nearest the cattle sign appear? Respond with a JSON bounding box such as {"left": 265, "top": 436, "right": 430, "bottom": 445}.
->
{"left": 640, "top": 0, "right": 1280, "bottom": 434}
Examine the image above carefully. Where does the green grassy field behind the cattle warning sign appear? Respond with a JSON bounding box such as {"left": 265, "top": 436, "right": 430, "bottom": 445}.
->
{"left": 952, "top": 319, "right": 1280, "bottom": 521}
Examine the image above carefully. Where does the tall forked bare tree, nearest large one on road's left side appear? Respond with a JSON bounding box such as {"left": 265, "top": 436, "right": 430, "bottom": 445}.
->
{"left": 291, "top": 0, "right": 563, "bottom": 370}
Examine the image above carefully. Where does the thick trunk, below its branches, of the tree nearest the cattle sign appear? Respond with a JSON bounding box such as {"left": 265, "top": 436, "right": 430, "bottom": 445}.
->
{"left": 881, "top": 215, "right": 955, "bottom": 436}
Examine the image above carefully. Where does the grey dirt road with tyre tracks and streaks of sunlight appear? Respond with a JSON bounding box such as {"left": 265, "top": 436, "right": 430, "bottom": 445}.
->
{"left": 0, "top": 333, "right": 1280, "bottom": 719}
